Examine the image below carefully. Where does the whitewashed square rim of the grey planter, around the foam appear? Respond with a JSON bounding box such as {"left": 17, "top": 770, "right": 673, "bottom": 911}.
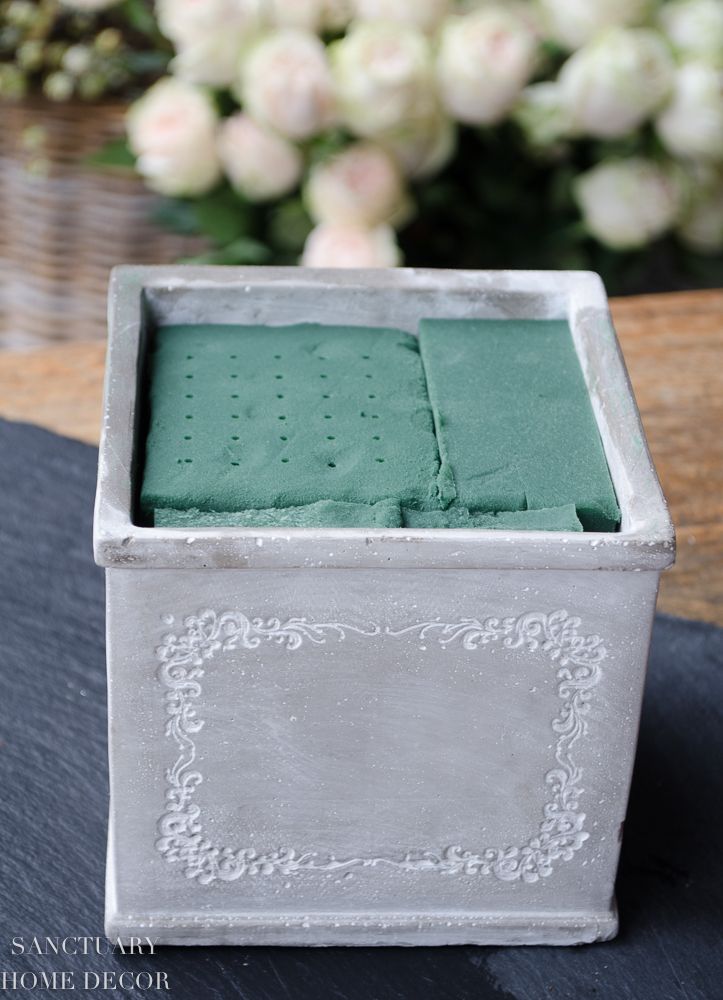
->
{"left": 94, "top": 265, "right": 675, "bottom": 571}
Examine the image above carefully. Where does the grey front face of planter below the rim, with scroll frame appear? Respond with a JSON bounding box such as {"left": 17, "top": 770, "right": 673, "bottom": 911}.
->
{"left": 107, "top": 569, "right": 657, "bottom": 944}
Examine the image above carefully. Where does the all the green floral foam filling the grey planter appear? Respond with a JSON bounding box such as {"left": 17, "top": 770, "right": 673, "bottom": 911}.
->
{"left": 141, "top": 320, "right": 620, "bottom": 531}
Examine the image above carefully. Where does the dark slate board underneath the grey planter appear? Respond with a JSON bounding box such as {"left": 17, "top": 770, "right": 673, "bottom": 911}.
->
{"left": 0, "top": 421, "right": 723, "bottom": 1000}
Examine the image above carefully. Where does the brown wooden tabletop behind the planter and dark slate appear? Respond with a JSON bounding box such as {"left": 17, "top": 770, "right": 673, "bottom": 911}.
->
{"left": 0, "top": 290, "right": 723, "bottom": 625}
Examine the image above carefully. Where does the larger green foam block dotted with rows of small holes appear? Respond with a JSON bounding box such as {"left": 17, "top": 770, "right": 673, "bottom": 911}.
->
{"left": 141, "top": 325, "right": 446, "bottom": 516}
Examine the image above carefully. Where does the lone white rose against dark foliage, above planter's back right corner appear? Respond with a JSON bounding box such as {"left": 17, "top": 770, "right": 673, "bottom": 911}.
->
{"left": 574, "top": 157, "right": 682, "bottom": 250}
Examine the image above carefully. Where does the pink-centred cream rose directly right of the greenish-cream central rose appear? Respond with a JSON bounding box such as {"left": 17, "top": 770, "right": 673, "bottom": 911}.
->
{"left": 437, "top": 5, "right": 537, "bottom": 125}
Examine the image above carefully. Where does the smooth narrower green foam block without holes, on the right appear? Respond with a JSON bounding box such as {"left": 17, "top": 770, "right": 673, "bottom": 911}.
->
{"left": 419, "top": 319, "right": 620, "bottom": 531}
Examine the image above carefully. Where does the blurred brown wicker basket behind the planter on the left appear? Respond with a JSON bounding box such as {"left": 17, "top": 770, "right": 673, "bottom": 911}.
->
{"left": 0, "top": 100, "right": 203, "bottom": 347}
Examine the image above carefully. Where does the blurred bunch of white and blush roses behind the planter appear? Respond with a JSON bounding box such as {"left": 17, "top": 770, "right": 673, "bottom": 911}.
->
{"left": 14, "top": 0, "right": 723, "bottom": 290}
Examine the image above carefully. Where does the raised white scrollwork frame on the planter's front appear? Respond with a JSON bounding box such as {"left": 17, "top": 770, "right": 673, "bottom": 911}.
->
{"left": 156, "top": 610, "right": 606, "bottom": 885}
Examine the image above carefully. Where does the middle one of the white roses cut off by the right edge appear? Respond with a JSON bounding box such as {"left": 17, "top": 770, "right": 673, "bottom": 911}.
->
{"left": 655, "top": 63, "right": 723, "bottom": 160}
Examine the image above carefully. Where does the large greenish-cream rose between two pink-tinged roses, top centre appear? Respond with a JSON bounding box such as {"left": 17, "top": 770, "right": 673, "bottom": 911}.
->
{"left": 329, "top": 22, "right": 436, "bottom": 136}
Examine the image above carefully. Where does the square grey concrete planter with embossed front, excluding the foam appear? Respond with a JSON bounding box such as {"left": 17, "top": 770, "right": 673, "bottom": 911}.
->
{"left": 95, "top": 268, "right": 674, "bottom": 945}
